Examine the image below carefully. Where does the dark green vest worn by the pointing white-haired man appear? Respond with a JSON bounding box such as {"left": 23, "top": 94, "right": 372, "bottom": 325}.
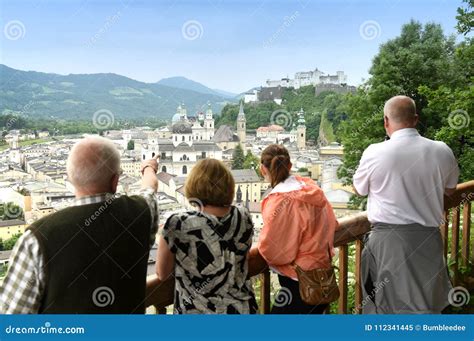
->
{"left": 29, "top": 196, "right": 151, "bottom": 314}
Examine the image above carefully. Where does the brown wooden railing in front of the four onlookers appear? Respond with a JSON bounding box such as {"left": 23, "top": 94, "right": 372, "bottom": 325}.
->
{"left": 146, "top": 180, "right": 474, "bottom": 314}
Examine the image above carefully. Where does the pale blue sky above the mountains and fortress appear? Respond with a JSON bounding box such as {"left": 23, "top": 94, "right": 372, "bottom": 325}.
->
{"left": 0, "top": 0, "right": 461, "bottom": 92}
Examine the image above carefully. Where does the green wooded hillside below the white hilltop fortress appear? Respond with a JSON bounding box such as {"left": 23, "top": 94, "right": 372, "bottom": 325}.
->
{"left": 216, "top": 86, "right": 346, "bottom": 142}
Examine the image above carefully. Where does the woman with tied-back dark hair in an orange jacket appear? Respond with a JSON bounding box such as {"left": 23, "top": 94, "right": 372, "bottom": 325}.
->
{"left": 252, "top": 144, "right": 337, "bottom": 314}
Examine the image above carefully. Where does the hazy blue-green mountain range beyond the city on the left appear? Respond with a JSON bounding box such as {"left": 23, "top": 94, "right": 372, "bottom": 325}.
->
{"left": 0, "top": 64, "right": 244, "bottom": 119}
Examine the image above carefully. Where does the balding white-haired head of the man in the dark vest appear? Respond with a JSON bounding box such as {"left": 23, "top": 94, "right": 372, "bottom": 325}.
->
{"left": 67, "top": 136, "right": 120, "bottom": 194}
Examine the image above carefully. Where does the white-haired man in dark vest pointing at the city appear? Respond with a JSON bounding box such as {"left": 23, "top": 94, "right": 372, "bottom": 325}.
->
{"left": 0, "top": 136, "right": 158, "bottom": 314}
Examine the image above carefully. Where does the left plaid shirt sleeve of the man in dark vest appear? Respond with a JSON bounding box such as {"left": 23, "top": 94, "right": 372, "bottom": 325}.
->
{"left": 0, "top": 230, "right": 44, "bottom": 314}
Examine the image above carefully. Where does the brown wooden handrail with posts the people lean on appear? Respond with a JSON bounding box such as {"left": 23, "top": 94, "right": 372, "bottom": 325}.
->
{"left": 146, "top": 180, "right": 474, "bottom": 313}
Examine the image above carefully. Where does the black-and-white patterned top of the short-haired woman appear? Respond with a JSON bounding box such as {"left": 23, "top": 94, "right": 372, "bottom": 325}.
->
{"left": 163, "top": 206, "right": 257, "bottom": 314}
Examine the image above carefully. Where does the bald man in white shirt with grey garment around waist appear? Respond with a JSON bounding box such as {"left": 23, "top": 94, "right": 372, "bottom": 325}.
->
{"left": 353, "top": 96, "right": 459, "bottom": 314}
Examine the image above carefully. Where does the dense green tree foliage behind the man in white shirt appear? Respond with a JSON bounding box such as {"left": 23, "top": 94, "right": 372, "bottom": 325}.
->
{"left": 337, "top": 17, "right": 474, "bottom": 207}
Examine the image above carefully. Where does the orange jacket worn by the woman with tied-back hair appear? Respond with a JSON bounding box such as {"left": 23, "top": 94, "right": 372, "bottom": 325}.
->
{"left": 258, "top": 176, "right": 338, "bottom": 279}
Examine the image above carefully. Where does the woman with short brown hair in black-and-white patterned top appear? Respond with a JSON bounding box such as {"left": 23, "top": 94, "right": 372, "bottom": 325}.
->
{"left": 156, "top": 159, "right": 257, "bottom": 314}
